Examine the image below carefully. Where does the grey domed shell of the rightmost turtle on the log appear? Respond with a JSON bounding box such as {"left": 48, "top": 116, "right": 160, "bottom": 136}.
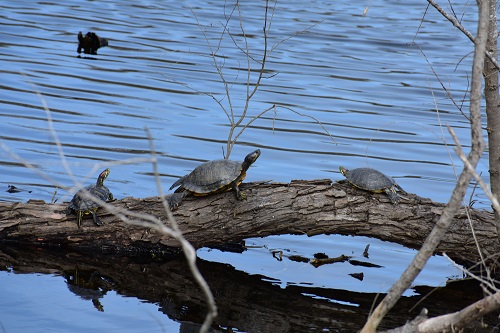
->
{"left": 344, "top": 168, "right": 396, "bottom": 193}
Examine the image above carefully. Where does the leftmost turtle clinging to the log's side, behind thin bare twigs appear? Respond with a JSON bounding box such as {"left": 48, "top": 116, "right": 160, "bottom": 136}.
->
{"left": 66, "top": 169, "right": 113, "bottom": 228}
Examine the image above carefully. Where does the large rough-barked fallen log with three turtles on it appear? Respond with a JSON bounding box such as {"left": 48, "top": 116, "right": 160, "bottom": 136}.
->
{"left": 0, "top": 180, "right": 500, "bottom": 263}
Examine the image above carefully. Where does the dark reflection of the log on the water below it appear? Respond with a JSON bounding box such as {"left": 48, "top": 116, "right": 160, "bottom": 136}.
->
{"left": 0, "top": 247, "right": 497, "bottom": 333}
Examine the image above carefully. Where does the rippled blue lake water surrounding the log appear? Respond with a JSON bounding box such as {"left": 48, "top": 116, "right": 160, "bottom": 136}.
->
{"left": 0, "top": 0, "right": 489, "bottom": 332}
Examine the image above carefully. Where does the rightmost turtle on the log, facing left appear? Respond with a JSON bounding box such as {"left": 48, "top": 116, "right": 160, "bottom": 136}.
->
{"left": 339, "top": 167, "right": 406, "bottom": 204}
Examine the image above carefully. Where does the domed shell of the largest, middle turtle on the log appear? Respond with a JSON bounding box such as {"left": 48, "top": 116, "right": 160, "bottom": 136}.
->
{"left": 171, "top": 159, "right": 246, "bottom": 195}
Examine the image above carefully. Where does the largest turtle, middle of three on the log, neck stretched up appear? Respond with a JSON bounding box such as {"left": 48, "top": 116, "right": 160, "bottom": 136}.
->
{"left": 168, "top": 149, "right": 260, "bottom": 209}
